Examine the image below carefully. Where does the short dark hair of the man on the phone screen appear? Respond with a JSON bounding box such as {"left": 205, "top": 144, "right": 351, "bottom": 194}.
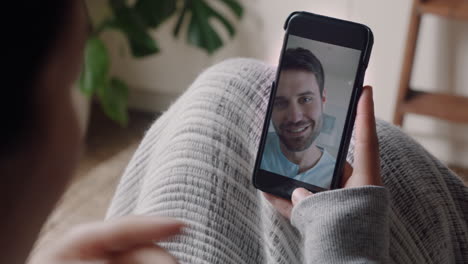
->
{"left": 281, "top": 48, "right": 325, "bottom": 95}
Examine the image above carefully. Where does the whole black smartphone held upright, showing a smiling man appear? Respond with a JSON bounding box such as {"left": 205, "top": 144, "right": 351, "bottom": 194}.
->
{"left": 253, "top": 12, "right": 373, "bottom": 199}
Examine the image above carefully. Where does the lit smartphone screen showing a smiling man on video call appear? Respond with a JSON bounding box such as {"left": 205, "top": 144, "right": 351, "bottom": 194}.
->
{"left": 260, "top": 34, "right": 361, "bottom": 189}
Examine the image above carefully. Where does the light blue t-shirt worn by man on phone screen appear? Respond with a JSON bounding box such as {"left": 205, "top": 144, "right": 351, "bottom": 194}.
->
{"left": 260, "top": 132, "right": 336, "bottom": 189}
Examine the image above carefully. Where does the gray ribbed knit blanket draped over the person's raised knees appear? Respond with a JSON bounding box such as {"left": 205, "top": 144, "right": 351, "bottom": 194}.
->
{"left": 107, "top": 59, "right": 468, "bottom": 263}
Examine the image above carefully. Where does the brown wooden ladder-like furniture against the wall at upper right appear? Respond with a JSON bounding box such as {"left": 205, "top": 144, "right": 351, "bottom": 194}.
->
{"left": 393, "top": 0, "right": 468, "bottom": 126}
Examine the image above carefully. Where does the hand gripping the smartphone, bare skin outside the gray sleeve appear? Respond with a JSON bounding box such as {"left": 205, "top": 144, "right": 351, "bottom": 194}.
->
{"left": 264, "top": 86, "right": 382, "bottom": 219}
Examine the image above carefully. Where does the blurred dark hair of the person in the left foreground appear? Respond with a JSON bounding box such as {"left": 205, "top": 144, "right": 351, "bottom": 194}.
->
{"left": 0, "top": 0, "right": 74, "bottom": 156}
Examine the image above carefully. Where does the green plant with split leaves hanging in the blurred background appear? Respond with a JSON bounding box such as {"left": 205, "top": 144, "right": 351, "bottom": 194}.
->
{"left": 79, "top": 0, "right": 243, "bottom": 126}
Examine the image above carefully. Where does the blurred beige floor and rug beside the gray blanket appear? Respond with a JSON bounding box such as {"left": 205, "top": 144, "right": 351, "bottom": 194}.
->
{"left": 29, "top": 105, "right": 468, "bottom": 260}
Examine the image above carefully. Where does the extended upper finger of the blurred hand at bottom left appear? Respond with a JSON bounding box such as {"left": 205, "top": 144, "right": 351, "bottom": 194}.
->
{"left": 58, "top": 216, "right": 184, "bottom": 258}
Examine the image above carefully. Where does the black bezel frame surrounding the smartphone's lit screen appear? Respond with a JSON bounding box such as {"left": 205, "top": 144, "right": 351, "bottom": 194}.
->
{"left": 252, "top": 11, "right": 374, "bottom": 199}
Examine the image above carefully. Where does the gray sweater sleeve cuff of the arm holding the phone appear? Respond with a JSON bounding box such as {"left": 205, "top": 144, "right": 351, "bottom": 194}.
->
{"left": 291, "top": 186, "right": 390, "bottom": 263}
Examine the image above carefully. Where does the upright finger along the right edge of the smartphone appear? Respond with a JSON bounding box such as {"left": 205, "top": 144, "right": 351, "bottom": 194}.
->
{"left": 353, "top": 86, "right": 380, "bottom": 184}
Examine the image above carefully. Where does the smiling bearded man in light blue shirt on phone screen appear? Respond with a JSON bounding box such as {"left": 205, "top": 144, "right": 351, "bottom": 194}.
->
{"left": 260, "top": 48, "right": 336, "bottom": 189}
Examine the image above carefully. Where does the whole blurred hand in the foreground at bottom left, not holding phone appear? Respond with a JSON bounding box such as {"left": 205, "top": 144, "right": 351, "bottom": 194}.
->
{"left": 29, "top": 216, "right": 184, "bottom": 264}
